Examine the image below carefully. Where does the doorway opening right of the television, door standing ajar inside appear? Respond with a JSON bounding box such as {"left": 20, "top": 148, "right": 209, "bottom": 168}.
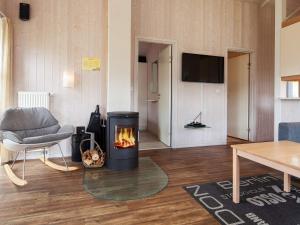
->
{"left": 227, "top": 51, "right": 251, "bottom": 144}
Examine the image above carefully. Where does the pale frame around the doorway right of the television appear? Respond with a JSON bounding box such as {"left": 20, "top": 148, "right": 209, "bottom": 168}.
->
{"left": 225, "top": 48, "right": 256, "bottom": 141}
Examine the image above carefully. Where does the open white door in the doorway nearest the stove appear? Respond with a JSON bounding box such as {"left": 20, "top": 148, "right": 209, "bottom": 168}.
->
{"left": 158, "top": 46, "right": 172, "bottom": 146}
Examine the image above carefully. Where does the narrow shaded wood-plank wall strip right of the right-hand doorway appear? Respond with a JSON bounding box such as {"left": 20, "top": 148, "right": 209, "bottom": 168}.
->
{"left": 256, "top": 4, "right": 275, "bottom": 141}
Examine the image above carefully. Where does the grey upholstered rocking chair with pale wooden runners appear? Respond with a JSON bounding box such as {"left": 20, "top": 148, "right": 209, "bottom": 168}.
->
{"left": 0, "top": 108, "right": 78, "bottom": 186}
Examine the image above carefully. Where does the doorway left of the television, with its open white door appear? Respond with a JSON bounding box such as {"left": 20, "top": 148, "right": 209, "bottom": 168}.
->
{"left": 134, "top": 41, "right": 172, "bottom": 150}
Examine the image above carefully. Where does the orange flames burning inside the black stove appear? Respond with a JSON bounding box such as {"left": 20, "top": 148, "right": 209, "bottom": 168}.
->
{"left": 115, "top": 128, "right": 135, "bottom": 148}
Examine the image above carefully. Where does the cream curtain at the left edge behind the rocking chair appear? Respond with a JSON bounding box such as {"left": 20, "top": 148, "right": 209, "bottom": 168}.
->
{"left": 0, "top": 17, "right": 13, "bottom": 164}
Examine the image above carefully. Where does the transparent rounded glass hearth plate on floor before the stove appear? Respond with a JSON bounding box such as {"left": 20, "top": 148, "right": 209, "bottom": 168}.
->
{"left": 83, "top": 157, "right": 168, "bottom": 201}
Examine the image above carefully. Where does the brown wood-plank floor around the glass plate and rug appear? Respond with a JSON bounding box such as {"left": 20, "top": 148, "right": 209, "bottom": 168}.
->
{"left": 0, "top": 146, "right": 273, "bottom": 225}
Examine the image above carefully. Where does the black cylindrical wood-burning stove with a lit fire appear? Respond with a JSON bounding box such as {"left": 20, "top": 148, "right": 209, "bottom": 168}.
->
{"left": 106, "top": 112, "right": 139, "bottom": 170}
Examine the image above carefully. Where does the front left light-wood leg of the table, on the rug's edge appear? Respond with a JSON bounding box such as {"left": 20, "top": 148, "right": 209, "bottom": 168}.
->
{"left": 232, "top": 149, "right": 240, "bottom": 203}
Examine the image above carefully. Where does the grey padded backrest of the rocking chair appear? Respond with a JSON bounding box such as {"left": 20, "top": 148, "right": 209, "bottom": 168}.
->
{"left": 0, "top": 108, "right": 60, "bottom": 138}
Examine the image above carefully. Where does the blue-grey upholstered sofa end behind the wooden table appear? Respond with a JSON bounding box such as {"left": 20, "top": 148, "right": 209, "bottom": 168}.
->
{"left": 278, "top": 122, "right": 300, "bottom": 143}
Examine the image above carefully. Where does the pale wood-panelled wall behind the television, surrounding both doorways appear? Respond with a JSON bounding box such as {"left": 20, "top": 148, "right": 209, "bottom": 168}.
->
{"left": 133, "top": 0, "right": 273, "bottom": 147}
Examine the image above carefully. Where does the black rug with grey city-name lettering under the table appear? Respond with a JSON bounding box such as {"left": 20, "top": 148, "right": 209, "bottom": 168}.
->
{"left": 184, "top": 174, "right": 300, "bottom": 225}
